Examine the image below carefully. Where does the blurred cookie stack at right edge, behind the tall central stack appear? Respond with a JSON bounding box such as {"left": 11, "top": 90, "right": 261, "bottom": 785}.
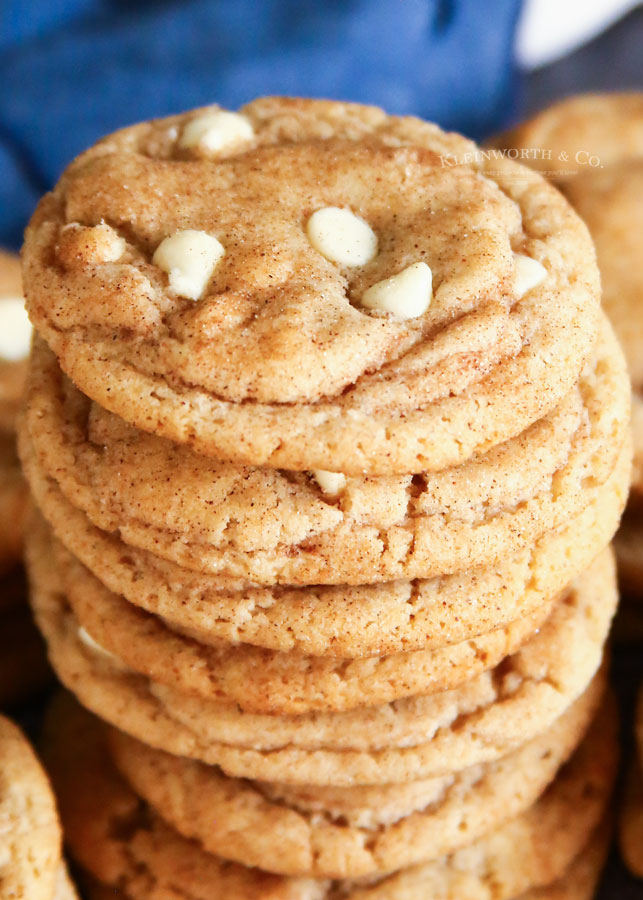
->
{"left": 498, "top": 93, "right": 643, "bottom": 596}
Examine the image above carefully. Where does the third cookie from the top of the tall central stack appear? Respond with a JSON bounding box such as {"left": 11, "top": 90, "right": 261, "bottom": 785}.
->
{"left": 21, "top": 412, "right": 630, "bottom": 657}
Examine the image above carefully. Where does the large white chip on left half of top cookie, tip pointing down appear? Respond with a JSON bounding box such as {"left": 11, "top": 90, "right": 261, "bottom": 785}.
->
{"left": 152, "top": 228, "right": 225, "bottom": 300}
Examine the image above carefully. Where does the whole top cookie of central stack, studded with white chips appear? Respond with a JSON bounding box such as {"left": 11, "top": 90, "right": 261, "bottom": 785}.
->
{"left": 24, "top": 98, "right": 599, "bottom": 474}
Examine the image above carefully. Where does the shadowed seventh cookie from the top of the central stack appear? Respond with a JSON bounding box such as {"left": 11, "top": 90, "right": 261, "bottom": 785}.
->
{"left": 40, "top": 692, "right": 617, "bottom": 900}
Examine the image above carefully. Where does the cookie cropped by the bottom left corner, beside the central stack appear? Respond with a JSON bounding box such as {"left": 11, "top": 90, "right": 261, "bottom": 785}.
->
{"left": 0, "top": 716, "right": 62, "bottom": 900}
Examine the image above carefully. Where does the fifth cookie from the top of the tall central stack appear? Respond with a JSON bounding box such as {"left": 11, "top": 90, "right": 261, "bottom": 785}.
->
{"left": 29, "top": 520, "right": 616, "bottom": 786}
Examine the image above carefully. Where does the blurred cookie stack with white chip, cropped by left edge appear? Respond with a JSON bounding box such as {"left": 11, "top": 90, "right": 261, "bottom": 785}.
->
{"left": 0, "top": 251, "right": 50, "bottom": 708}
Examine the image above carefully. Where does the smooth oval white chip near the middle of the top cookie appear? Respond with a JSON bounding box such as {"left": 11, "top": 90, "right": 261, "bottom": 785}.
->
{"left": 306, "top": 206, "right": 377, "bottom": 266}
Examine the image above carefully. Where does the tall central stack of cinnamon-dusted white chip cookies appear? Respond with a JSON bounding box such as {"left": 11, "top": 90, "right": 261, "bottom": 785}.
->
{"left": 20, "top": 98, "right": 630, "bottom": 900}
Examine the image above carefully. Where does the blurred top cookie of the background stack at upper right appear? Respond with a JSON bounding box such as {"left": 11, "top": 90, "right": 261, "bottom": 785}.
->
{"left": 493, "top": 91, "right": 643, "bottom": 185}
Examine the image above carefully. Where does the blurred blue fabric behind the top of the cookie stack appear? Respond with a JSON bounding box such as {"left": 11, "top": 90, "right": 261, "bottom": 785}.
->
{"left": 0, "top": 0, "right": 520, "bottom": 247}
